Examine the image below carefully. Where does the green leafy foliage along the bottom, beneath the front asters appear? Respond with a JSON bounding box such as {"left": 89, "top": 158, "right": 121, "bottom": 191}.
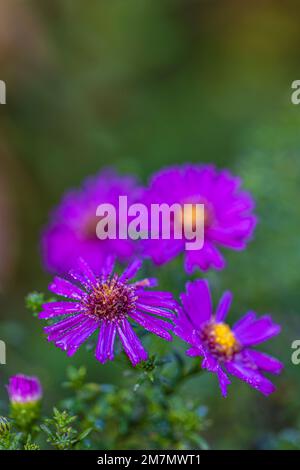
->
{"left": 0, "top": 357, "right": 208, "bottom": 450}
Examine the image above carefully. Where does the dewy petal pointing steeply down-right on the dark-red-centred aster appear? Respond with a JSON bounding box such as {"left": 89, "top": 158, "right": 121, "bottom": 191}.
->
{"left": 117, "top": 320, "right": 148, "bottom": 366}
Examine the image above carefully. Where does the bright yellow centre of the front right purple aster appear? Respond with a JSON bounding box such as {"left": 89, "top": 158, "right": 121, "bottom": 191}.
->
{"left": 201, "top": 322, "right": 240, "bottom": 359}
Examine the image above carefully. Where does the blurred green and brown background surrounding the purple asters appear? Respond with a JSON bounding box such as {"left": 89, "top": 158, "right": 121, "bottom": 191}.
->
{"left": 0, "top": 0, "right": 300, "bottom": 449}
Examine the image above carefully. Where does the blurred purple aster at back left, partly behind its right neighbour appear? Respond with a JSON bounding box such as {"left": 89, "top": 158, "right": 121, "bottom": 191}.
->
{"left": 41, "top": 169, "right": 140, "bottom": 274}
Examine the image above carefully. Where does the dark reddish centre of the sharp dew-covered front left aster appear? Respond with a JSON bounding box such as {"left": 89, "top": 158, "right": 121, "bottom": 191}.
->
{"left": 85, "top": 276, "right": 136, "bottom": 322}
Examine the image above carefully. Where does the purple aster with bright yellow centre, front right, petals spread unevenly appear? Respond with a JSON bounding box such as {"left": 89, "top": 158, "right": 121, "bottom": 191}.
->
{"left": 174, "top": 280, "right": 283, "bottom": 396}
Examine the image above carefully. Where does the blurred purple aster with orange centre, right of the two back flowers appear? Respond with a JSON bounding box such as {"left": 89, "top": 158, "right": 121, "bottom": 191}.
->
{"left": 143, "top": 165, "right": 256, "bottom": 274}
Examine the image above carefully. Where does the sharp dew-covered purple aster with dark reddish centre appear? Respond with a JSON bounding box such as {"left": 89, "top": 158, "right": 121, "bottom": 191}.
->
{"left": 39, "top": 257, "right": 177, "bottom": 366}
